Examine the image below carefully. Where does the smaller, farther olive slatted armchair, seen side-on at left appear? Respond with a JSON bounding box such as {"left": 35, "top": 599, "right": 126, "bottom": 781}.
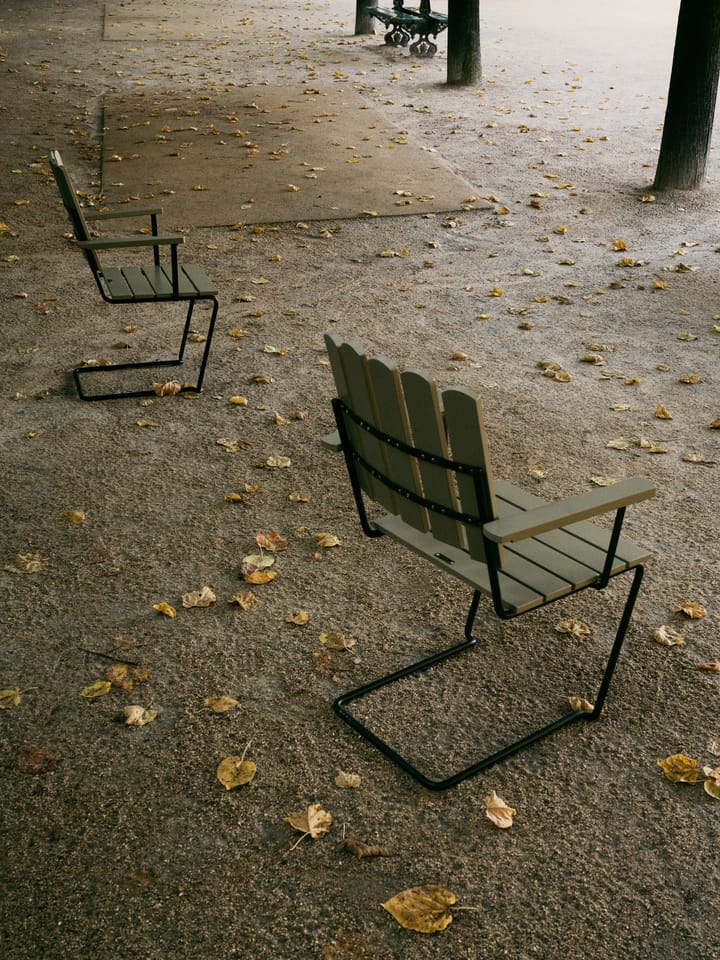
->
{"left": 48, "top": 150, "right": 218, "bottom": 400}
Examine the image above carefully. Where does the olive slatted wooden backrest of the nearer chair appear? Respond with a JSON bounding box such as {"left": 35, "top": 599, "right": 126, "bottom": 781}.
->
{"left": 325, "top": 334, "right": 497, "bottom": 560}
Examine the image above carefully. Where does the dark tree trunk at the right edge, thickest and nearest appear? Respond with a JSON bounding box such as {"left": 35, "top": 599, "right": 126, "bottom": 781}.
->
{"left": 655, "top": 0, "right": 720, "bottom": 190}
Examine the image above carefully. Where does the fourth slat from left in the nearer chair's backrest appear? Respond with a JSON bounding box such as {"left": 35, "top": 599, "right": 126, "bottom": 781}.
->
{"left": 400, "top": 370, "right": 466, "bottom": 549}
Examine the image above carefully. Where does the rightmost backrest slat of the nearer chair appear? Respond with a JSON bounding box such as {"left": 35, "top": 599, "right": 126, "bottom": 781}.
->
{"left": 442, "top": 387, "right": 502, "bottom": 563}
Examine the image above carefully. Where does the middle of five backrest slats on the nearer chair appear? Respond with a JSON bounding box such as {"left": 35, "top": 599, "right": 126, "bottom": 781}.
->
{"left": 367, "top": 357, "right": 429, "bottom": 533}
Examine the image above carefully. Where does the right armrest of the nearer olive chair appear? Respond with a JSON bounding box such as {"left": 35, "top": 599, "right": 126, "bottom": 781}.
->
{"left": 483, "top": 477, "right": 655, "bottom": 543}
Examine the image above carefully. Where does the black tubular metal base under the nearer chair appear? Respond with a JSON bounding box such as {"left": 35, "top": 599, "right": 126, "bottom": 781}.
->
{"left": 333, "top": 566, "right": 644, "bottom": 790}
